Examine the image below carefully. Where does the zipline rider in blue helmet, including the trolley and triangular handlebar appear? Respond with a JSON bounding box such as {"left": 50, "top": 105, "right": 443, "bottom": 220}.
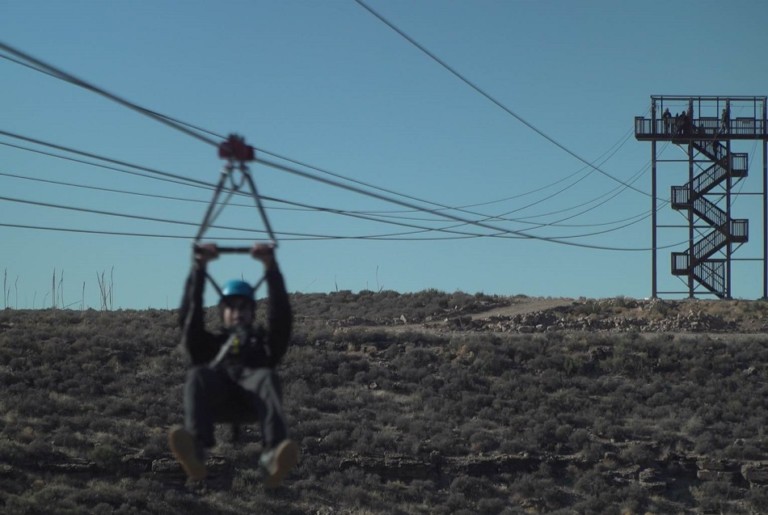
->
{"left": 168, "top": 136, "right": 299, "bottom": 488}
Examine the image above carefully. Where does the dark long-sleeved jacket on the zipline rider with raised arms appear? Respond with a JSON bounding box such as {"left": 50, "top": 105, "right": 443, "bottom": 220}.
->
{"left": 179, "top": 263, "right": 293, "bottom": 368}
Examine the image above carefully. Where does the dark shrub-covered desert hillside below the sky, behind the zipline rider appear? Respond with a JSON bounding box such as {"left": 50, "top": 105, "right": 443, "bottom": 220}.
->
{"left": 0, "top": 291, "right": 768, "bottom": 514}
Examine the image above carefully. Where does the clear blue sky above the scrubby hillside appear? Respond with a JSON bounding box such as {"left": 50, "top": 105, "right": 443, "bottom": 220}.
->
{"left": 0, "top": 0, "right": 768, "bottom": 309}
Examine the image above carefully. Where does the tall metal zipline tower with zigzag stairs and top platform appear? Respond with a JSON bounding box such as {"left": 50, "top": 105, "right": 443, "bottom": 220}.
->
{"left": 635, "top": 95, "right": 768, "bottom": 299}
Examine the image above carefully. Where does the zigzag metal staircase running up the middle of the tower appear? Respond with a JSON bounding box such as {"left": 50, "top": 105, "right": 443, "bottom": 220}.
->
{"left": 672, "top": 139, "right": 749, "bottom": 298}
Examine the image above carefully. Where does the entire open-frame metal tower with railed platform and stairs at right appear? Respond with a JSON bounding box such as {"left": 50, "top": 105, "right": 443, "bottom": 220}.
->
{"left": 635, "top": 95, "right": 768, "bottom": 299}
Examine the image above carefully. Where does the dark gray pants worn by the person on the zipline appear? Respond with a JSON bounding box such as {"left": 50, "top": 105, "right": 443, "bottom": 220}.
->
{"left": 184, "top": 366, "right": 287, "bottom": 449}
